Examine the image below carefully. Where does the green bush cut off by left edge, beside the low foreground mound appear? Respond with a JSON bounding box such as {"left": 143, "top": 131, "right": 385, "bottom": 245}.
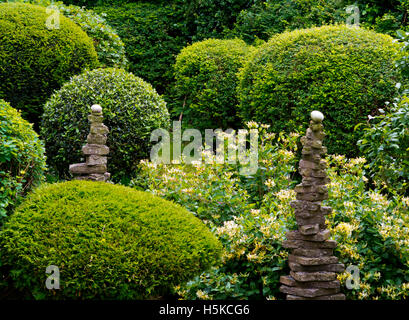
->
{"left": 0, "top": 99, "right": 45, "bottom": 225}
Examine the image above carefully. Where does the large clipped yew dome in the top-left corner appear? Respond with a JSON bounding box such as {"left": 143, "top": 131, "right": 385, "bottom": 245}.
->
{"left": 0, "top": 3, "right": 98, "bottom": 122}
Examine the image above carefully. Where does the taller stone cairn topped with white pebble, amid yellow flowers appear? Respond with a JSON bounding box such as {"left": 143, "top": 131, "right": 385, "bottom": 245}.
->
{"left": 280, "top": 111, "right": 345, "bottom": 300}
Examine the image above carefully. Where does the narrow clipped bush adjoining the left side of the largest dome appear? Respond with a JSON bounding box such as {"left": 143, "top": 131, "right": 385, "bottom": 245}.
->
{"left": 174, "top": 39, "right": 253, "bottom": 129}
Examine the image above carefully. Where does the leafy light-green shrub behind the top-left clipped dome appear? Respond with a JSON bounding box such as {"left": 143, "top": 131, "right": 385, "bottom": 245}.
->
{"left": 0, "top": 0, "right": 128, "bottom": 68}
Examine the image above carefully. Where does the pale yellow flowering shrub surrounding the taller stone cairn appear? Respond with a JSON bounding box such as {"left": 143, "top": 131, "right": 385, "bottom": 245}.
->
{"left": 133, "top": 123, "right": 409, "bottom": 299}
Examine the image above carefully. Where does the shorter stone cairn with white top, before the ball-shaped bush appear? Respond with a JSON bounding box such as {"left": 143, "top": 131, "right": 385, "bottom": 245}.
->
{"left": 69, "top": 105, "right": 111, "bottom": 182}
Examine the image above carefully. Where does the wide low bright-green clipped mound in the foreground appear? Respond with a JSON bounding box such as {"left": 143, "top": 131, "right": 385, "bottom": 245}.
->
{"left": 0, "top": 181, "right": 221, "bottom": 299}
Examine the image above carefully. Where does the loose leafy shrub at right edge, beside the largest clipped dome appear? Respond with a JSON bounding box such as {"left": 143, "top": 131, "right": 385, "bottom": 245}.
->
{"left": 358, "top": 96, "right": 409, "bottom": 195}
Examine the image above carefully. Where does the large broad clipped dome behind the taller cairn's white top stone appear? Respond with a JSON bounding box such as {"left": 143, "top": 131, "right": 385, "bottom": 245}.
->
{"left": 238, "top": 25, "right": 400, "bottom": 155}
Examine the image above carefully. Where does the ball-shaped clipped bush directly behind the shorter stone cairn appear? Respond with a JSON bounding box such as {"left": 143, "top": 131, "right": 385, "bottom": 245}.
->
{"left": 41, "top": 68, "right": 170, "bottom": 178}
